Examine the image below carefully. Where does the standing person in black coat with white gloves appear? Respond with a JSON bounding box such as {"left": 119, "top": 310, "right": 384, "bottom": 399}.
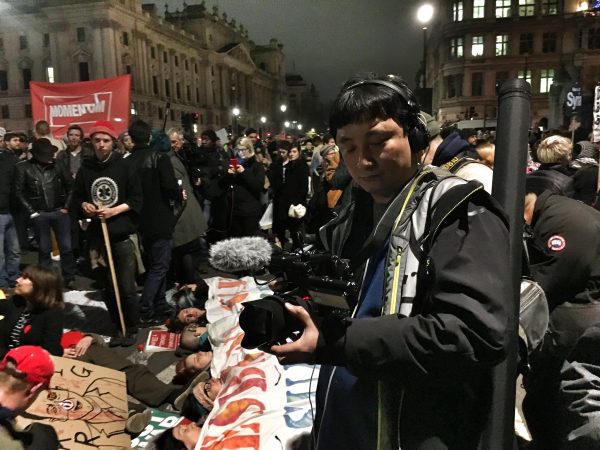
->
{"left": 269, "top": 141, "right": 309, "bottom": 249}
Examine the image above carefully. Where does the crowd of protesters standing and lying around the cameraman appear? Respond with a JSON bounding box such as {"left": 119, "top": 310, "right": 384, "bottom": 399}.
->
{"left": 0, "top": 103, "right": 600, "bottom": 450}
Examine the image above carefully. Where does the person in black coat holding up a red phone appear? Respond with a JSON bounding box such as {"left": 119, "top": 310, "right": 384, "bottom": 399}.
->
{"left": 227, "top": 138, "right": 265, "bottom": 237}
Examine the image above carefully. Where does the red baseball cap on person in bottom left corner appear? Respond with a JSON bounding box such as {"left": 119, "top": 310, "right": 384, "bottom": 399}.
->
{"left": 0, "top": 345, "right": 54, "bottom": 386}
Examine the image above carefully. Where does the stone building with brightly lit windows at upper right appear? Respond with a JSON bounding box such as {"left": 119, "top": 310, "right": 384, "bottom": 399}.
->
{"left": 427, "top": 0, "right": 600, "bottom": 128}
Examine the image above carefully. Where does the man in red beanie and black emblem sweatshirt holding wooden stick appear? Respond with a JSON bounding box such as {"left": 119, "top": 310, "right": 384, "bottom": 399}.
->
{"left": 71, "top": 121, "right": 142, "bottom": 346}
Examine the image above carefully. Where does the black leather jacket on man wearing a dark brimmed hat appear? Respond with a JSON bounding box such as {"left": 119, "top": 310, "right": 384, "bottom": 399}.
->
{"left": 15, "top": 158, "right": 73, "bottom": 214}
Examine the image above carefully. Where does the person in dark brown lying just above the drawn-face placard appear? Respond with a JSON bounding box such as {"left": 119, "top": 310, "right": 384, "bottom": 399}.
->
{"left": 61, "top": 331, "right": 183, "bottom": 407}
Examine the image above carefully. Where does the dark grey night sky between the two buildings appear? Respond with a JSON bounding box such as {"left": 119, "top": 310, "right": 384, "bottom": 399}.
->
{"left": 166, "top": 0, "right": 423, "bottom": 102}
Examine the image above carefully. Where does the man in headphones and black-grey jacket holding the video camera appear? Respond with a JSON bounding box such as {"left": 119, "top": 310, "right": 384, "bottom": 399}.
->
{"left": 270, "top": 75, "right": 510, "bottom": 450}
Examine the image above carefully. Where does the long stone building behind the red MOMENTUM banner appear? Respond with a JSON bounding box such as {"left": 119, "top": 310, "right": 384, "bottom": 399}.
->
{"left": 0, "top": 0, "right": 286, "bottom": 134}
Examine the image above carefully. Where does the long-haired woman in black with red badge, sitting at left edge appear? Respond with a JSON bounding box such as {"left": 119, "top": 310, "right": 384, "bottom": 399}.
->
{"left": 0, "top": 266, "right": 64, "bottom": 357}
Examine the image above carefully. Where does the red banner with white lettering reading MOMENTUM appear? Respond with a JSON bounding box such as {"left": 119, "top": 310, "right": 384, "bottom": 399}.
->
{"left": 30, "top": 75, "right": 131, "bottom": 139}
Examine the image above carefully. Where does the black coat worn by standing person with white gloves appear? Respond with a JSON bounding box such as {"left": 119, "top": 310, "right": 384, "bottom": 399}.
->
{"left": 269, "top": 158, "right": 309, "bottom": 220}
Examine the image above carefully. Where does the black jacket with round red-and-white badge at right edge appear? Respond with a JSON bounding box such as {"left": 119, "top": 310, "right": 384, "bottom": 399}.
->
{"left": 527, "top": 192, "right": 600, "bottom": 310}
